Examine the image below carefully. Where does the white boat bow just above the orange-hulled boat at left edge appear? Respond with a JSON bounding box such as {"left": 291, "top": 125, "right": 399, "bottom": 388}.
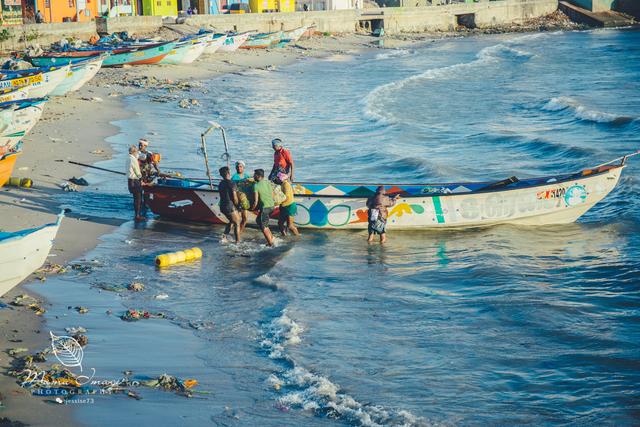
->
{"left": 0, "top": 98, "right": 47, "bottom": 156}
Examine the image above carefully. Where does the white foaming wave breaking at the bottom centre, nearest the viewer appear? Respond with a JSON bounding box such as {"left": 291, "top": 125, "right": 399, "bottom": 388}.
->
{"left": 260, "top": 310, "right": 428, "bottom": 427}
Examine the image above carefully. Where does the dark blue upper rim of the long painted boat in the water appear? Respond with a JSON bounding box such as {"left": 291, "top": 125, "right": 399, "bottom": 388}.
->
{"left": 145, "top": 164, "right": 626, "bottom": 199}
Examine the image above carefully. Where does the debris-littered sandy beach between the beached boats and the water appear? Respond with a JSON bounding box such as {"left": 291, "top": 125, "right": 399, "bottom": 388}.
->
{"left": 0, "top": 12, "right": 588, "bottom": 425}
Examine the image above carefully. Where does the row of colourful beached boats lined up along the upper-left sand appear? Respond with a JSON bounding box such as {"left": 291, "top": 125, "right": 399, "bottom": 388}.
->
{"left": 0, "top": 26, "right": 311, "bottom": 187}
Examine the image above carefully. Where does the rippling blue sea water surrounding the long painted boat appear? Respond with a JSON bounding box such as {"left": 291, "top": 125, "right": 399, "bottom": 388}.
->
{"left": 31, "top": 30, "right": 640, "bottom": 426}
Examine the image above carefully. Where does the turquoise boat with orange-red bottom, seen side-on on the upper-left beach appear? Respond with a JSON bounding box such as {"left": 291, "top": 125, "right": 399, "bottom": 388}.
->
{"left": 28, "top": 41, "right": 176, "bottom": 67}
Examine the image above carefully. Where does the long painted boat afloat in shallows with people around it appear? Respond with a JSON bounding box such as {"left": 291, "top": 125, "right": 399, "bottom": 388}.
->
{"left": 145, "top": 157, "right": 627, "bottom": 230}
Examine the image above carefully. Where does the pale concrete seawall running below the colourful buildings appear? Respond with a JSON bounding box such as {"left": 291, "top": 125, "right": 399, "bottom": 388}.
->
{"left": 1, "top": 0, "right": 558, "bottom": 50}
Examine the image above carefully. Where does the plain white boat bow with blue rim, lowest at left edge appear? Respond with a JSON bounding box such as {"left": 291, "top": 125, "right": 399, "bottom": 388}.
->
{"left": 0, "top": 214, "right": 64, "bottom": 296}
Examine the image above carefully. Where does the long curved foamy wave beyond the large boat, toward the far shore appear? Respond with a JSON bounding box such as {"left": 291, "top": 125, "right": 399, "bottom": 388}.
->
{"left": 364, "top": 43, "right": 533, "bottom": 124}
